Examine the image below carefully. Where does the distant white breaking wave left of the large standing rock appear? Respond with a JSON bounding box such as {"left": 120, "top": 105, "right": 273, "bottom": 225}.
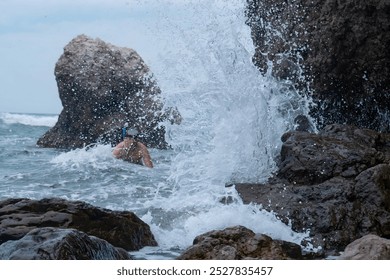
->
{"left": 0, "top": 113, "right": 58, "bottom": 127}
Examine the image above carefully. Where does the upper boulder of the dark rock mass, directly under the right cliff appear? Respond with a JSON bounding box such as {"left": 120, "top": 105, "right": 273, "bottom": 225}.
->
{"left": 278, "top": 124, "right": 390, "bottom": 184}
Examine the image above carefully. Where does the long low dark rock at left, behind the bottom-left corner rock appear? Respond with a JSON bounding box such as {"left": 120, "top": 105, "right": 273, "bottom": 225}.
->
{"left": 0, "top": 198, "right": 157, "bottom": 251}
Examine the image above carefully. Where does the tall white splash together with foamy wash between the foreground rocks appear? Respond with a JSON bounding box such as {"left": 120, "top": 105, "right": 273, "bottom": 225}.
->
{"left": 129, "top": 0, "right": 316, "bottom": 256}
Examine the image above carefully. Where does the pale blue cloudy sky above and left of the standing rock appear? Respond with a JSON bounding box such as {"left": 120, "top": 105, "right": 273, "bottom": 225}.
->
{"left": 0, "top": 0, "right": 189, "bottom": 114}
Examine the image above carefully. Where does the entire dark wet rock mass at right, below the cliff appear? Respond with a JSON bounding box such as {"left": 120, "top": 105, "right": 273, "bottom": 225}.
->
{"left": 236, "top": 125, "right": 390, "bottom": 254}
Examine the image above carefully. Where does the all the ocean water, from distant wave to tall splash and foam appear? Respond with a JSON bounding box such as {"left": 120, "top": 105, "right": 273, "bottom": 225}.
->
{"left": 0, "top": 0, "right": 315, "bottom": 259}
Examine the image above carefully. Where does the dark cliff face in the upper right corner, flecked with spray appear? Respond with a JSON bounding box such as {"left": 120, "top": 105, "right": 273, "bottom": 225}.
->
{"left": 247, "top": 0, "right": 390, "bottom": 131}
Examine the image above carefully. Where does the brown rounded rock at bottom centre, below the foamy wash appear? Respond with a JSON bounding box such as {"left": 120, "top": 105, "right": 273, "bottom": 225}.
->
{"left": 178, "top": 226, "right": 302, "bottom": 260}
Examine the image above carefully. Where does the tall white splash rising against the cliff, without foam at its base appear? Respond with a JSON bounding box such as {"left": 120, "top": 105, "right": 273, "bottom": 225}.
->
{"left": 152, "top": 0, "right": 307, "bottom": 182}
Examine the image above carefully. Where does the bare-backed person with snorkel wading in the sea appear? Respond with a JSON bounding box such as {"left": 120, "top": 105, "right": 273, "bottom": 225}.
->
{"left": 112, "top": 128, "right": 153, "bottom": 168}
